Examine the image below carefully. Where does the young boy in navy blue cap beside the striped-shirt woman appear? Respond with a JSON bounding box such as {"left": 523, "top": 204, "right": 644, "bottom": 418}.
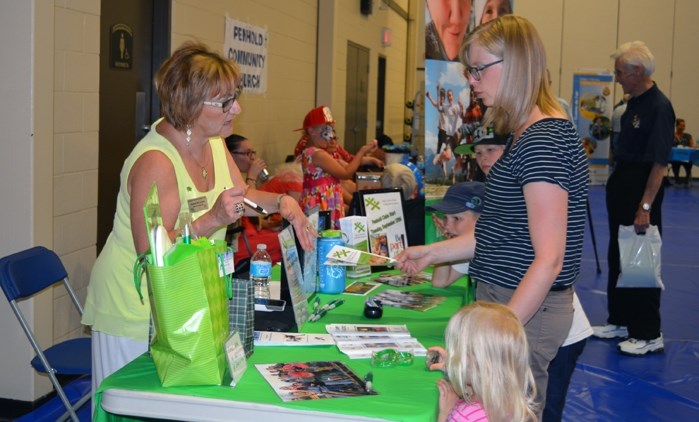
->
{"left": 427, "top": 182, "right": 485, "bottom": 287}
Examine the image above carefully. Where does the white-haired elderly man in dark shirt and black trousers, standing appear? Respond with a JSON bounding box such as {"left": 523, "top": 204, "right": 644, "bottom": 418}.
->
{"left": 593, "top": 41, "right": 675, "bottom": 356}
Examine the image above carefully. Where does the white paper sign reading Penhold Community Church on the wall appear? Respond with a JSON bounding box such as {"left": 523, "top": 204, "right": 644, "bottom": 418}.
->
{"left": 223, "top": 18, "right": 268, "bottom": 94}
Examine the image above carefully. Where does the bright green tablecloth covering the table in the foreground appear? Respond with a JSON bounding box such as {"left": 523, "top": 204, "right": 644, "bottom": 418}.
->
{"left": 94, "top": 272, "right": 471, "bottom": 422}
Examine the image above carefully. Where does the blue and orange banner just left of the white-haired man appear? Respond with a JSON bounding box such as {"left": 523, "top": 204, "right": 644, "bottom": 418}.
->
{"left": 572, "top": 70, "right": 614, "bottom": 185}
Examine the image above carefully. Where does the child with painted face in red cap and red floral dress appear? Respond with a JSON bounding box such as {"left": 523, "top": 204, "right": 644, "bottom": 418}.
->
{"left": 301, "top": 106, "right": 377, "bottom": 229}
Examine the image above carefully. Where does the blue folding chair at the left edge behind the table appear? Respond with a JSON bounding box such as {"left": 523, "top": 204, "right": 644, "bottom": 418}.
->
{"left": 0, "top": 246, "right": 92, "bottom": 422}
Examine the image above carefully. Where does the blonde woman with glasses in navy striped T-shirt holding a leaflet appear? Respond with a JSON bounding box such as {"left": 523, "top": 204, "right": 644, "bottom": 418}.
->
{"left": 397, "top": 15, "right": 589, "bottom": 418}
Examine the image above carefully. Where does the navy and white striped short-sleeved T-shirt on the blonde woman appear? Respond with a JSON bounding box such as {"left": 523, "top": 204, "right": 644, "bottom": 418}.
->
{"left": 469, "top": 118, "right": 589, "bottom": 289}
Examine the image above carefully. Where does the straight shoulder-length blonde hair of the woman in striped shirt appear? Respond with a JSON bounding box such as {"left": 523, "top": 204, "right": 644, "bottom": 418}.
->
{"left": 459, "top": 15, "right": 564, "bottom": 134}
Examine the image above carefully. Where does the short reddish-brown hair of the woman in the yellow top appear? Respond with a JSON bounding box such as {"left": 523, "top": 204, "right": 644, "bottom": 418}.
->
{"left": 153, "top": 41, "right": 240, "bottom": 130}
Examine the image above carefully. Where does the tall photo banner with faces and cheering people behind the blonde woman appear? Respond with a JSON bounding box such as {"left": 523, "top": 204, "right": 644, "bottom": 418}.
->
{"left": 423, "top": 0, "right": 514, "bottom": 186}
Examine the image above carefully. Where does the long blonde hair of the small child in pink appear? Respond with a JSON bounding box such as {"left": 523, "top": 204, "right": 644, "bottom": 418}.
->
{"left": 445, "top": 301, "right": 537, "bottom": 422}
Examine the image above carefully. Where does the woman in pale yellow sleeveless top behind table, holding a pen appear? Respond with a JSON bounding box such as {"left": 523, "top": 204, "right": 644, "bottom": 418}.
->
{"left": 82, "top": 42, "right": 316, "bottom": 398}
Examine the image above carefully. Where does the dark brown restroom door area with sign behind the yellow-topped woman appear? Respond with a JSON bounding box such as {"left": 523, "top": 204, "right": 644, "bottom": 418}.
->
{"left": 97, "top": 0, "right": 170, "bottom": 252}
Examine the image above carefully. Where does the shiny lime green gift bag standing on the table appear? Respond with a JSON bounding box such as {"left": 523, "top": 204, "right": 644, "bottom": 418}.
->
{"left": 134, "top": 238, "right": 228, "bottom": 387}
